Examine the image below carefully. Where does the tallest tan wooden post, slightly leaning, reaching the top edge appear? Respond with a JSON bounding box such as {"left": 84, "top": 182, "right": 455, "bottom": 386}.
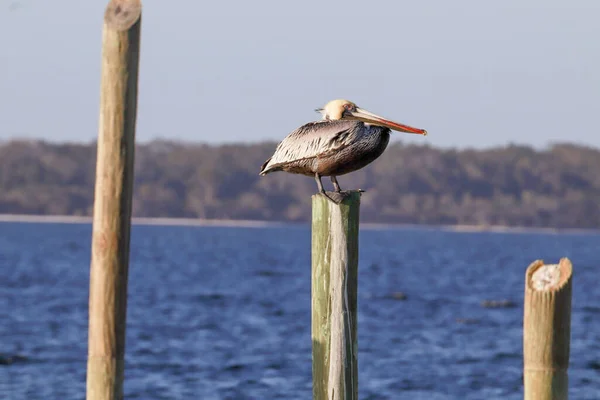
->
{"left": 87, "top": 0, "right": 142, "bottom": 400}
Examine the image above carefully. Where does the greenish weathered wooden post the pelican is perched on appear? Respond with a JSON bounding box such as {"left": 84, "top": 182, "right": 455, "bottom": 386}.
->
{"left": 311, "top": 192, "right": 360, "bottom": 400}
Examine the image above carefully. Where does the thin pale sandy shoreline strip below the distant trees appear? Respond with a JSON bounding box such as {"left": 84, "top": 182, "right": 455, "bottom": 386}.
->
{"left": 0, "top": 214, "right": 600, "bottom": 234}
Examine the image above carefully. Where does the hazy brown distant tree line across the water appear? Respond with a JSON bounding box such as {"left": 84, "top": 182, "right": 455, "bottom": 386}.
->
{"left": 0, "top": 141, "right": 600, "bottom": 228}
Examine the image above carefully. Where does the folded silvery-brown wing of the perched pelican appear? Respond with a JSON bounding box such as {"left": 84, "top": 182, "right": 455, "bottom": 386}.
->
{"left": 261, "top": 121, "right": 359, "bottom": 175}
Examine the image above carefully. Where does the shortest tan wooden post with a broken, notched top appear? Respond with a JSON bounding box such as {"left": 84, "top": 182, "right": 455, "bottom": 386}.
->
{"left": 523, "top": 258, "right": 573, "bottom": 400}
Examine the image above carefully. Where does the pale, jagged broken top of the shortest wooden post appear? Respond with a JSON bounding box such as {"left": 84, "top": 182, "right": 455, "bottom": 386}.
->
{"left": 526, "top": 257, "right": 573, "bottom": 292}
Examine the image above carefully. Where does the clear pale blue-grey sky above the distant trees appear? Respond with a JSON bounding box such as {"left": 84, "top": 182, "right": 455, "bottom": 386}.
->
{"left": 0, "top": 0, "right": 600, "bottom": 148}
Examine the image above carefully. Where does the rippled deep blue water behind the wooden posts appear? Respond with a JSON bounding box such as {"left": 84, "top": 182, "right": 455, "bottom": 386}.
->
{"left": 0, "top": 223, "right": 600, "bottom": 400}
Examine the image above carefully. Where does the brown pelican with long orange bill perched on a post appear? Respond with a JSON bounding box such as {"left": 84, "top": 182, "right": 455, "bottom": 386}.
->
{"left": 260, "top": 100, "right": 427, "bottom": 194}
